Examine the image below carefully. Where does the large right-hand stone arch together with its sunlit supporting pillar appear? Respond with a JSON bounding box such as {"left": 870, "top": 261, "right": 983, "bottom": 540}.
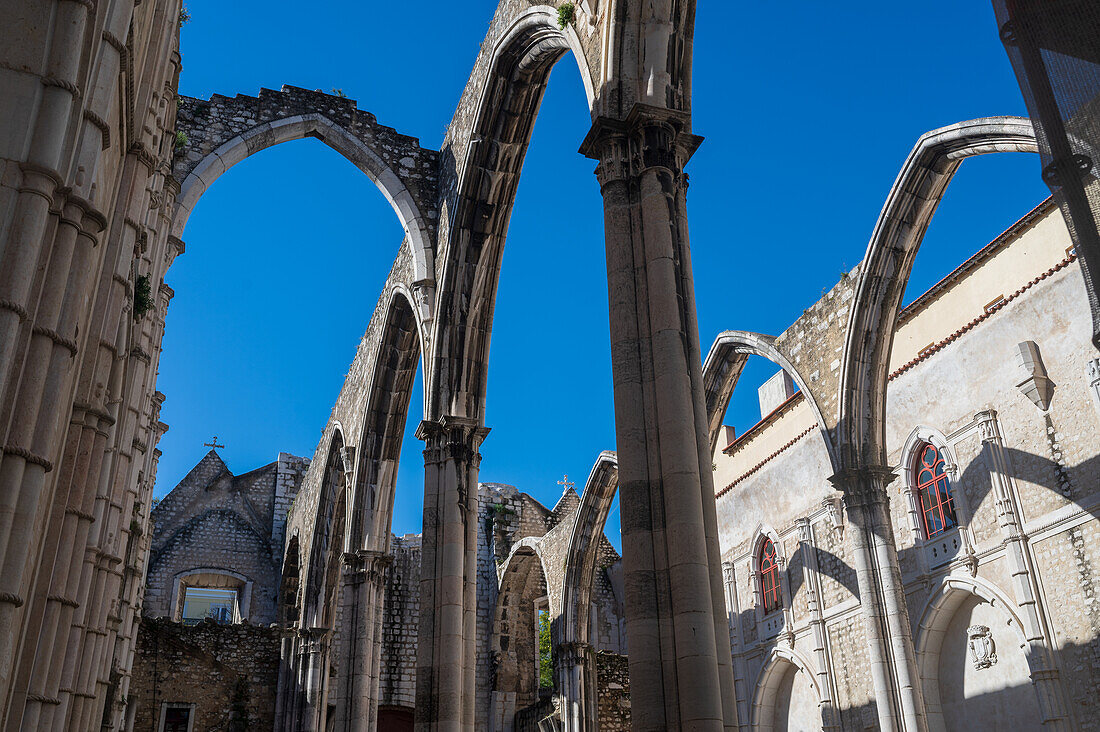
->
{"left": 832, "top": 117, "right": 1036, "bottom": 730}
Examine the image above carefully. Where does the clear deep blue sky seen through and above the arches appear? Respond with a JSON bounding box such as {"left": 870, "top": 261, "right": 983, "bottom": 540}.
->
{"left": 157, "top": 0, "right": 1046, "bottom": 544}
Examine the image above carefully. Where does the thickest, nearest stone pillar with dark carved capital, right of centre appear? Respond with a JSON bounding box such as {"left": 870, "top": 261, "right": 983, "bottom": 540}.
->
{"left": 581, "top": 103, "right": 736, "bottom": 730}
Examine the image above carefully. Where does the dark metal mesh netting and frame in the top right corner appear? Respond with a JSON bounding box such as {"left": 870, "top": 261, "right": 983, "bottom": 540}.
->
{"left": 993, "top": 0, "right": 1100, "bottom": 349}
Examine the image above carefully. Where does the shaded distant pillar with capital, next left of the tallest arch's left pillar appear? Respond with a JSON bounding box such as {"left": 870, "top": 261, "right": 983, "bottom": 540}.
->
{"left": 336, "top": 549, "right": 393, "bottom": 732}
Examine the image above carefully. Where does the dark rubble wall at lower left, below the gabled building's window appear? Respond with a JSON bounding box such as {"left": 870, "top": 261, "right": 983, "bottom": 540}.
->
{"left": 131, "top": 618, "right": 281, "bottom": 730}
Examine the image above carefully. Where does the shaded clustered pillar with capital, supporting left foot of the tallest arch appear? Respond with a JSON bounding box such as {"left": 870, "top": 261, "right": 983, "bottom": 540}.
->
{"left": 416, "top": 416, "right": 488, "bottom": 731}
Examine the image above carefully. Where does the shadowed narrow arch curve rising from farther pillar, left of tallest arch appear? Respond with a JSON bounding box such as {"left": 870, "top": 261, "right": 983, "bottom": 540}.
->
{"left": 349, "top": 283, "right": 427, "bottom": 553}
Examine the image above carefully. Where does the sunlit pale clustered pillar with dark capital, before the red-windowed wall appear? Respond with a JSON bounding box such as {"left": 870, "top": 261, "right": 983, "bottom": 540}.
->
{"left": 829, "top": 468, "right": 928, "bottom": 732}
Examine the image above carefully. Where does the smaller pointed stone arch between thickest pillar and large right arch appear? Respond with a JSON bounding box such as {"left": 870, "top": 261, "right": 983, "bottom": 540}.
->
{"left": 703, "top": 330, "right": 837, "bottom": 470}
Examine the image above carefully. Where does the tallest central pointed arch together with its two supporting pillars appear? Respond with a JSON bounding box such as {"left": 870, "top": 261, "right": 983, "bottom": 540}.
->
{"left": 418, "top": 1, "right": 734, "bottom": 729}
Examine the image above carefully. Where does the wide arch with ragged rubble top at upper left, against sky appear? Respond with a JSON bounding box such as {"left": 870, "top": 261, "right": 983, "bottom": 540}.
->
{"left": 171, "top": 86, "right": 439, "bottom": 281}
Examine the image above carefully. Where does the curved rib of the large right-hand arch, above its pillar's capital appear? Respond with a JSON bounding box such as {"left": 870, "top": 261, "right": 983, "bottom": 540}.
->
{"left": 835, "top": 117, "right": 1037, "bottom": 469}
